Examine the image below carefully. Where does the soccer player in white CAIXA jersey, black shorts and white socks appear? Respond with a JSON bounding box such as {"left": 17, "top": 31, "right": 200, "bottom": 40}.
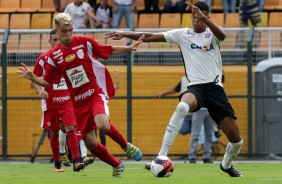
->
{"left": 105, "top": 1, "right": 243, "bottom": 177}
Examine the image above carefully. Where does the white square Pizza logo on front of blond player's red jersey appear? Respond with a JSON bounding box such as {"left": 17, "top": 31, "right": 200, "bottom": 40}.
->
{"left": 66, "top": 65, "right": 89, "bottom": 88}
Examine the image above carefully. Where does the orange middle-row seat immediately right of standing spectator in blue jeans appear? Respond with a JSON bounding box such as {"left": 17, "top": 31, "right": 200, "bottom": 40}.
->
{"left": 138, "top": 13, "right": 160, "bottom": 28}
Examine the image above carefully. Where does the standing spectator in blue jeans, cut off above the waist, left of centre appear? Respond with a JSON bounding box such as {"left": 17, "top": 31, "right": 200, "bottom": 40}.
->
{"left": 113, "top": 0, "right": 137, "bottom": 30}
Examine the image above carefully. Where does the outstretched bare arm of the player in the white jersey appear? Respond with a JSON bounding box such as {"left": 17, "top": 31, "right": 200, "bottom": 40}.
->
{"left": 104, "top": 31, "right": 166, "bottom": 42}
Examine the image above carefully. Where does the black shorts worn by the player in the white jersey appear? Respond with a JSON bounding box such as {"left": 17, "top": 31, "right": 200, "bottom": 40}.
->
{"left": 179, "top": 83, "right": 237, "bottom": 124}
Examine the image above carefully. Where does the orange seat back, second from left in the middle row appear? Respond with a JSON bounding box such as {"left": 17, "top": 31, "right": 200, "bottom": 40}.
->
{"left": 10, "top": 13, "right": 30, "bottom": 29}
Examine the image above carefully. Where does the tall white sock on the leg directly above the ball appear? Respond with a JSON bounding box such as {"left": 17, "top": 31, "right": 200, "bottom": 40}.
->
{"left": 158, "top": 102, "right": 189, "bottom": 156}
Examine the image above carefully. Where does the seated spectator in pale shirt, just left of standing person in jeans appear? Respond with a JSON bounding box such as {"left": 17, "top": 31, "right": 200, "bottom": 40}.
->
{"left": 93, "top": 0, "right": 113, "bottom": 28}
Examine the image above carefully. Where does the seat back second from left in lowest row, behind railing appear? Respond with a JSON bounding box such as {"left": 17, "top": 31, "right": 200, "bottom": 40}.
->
{"left": 19, "top": 33, "right": 40, "bottom": 51}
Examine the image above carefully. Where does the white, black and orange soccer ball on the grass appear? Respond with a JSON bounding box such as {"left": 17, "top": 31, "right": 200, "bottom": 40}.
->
{"left": 151, "top": 156, "right": 174, "bottom": 177}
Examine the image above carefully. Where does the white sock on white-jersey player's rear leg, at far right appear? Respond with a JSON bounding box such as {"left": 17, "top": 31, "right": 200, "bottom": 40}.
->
{"left": 221, "top": 139, "right": 243, "bottom": 169}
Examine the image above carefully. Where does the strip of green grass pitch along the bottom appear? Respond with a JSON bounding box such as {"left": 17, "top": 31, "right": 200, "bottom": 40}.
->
{"left": 0, "top": 162, "right": 282, "bottom": 184}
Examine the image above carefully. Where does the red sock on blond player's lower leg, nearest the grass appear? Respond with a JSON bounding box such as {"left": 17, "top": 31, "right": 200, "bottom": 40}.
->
{"left": 91, "top": 143, "right": 120, "bottom": 167}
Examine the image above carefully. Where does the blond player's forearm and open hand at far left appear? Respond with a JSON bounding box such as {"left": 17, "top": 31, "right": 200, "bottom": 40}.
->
{"left": 17, "top": 63, "right": 49, "bottom": 87}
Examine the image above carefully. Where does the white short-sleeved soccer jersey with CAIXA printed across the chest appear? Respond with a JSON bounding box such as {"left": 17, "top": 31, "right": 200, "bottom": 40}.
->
{"left": 163, "top": 28, "right": 222, "bottom": 86}
